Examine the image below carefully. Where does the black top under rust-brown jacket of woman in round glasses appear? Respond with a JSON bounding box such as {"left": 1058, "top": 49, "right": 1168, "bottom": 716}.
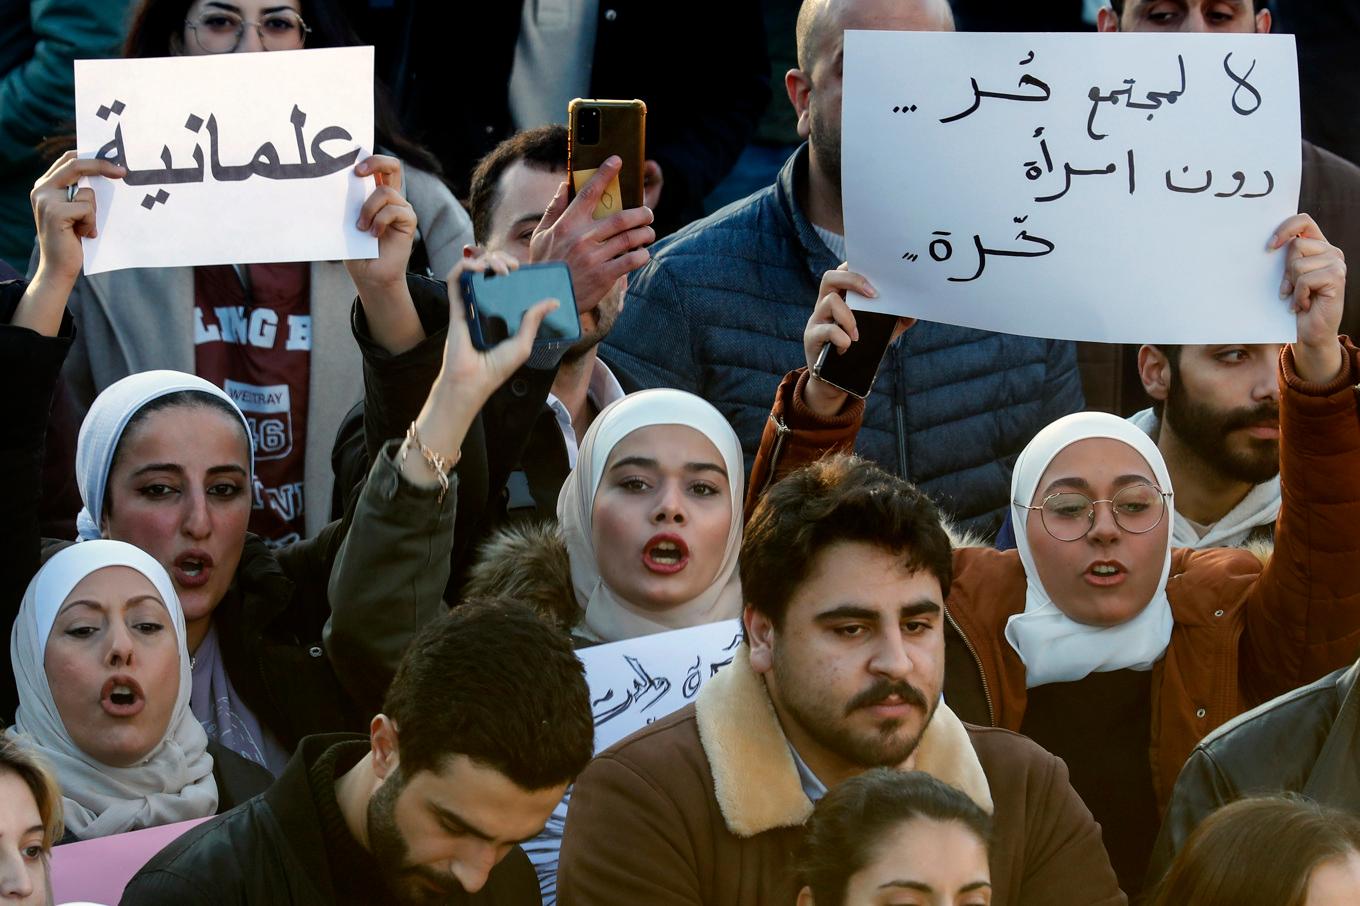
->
{"left": 1020, "top": 671, "right": 1159, "bottom": 899}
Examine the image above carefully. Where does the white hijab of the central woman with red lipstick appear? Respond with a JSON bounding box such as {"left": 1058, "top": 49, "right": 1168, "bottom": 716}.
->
{"left": 558, "top": 389, "right": 745, "bottom": 642}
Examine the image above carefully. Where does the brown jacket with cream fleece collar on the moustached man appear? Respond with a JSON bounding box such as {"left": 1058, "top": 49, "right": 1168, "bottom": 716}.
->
{"left": 558, "top": 645, "right": 1126, "bottom": 906}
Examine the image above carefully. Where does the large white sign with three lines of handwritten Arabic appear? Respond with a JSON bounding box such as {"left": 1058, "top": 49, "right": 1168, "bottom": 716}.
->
{"left": 842, "top": 31, "right": 1300, "bottom": 343}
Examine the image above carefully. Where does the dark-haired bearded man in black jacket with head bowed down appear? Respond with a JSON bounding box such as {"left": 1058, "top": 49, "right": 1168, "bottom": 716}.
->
{"left": 121, "top": 601, "right": 594, "bottom": 906}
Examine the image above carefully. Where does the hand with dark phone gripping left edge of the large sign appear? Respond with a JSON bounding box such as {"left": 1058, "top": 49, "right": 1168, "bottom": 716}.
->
{"left": 802, "top": 264, "right": 915, "bottom": 408}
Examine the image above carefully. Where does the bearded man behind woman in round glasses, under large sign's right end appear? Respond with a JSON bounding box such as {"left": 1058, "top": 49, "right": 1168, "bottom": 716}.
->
{"left": 1129, "top": 343, "right": 1281, "bottom": 548}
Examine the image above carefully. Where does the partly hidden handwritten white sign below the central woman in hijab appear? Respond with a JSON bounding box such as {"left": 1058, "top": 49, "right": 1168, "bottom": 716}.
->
{"left": 524, "top": 620, "right": 743, "bottom": 906}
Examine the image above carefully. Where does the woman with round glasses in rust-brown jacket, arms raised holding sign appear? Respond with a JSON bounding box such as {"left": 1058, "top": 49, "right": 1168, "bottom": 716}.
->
{"left": 749, "top": 215, "right": 1360, "bottom": 892}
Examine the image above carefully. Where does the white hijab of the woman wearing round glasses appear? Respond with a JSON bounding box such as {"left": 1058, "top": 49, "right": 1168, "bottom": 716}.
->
{"left": 1006, "top": 412, "right": 1174, "bottom": 688}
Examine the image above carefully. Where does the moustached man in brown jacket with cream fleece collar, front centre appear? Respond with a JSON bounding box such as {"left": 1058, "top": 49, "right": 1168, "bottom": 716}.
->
{"left": 558, "top": 456, "right": 1125, "bottom": 906}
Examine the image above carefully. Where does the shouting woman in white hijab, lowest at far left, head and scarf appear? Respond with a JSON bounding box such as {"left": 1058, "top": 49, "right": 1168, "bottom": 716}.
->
{"left": 8, "top": 540, "right": 261, "bottom": 839}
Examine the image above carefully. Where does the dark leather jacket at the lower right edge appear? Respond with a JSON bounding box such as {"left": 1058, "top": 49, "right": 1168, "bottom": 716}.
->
{"left": 1148, "top": 662, "right": 1360, "bottom": 886}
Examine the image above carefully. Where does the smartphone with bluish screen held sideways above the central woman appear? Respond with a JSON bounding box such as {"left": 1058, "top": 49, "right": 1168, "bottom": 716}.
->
{"left": 458, "top": 261, "right": 581, "bottom": 350}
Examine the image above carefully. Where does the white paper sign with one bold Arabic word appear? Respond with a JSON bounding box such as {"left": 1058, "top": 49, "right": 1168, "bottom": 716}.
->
{"left": 75, "top": 48, "right": 378, "bottom": 273}
